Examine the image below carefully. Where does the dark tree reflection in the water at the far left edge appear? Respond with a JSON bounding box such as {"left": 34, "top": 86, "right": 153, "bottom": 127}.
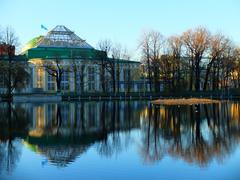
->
{"left": 0, "top": 103, "right": 29, "bottom": 174}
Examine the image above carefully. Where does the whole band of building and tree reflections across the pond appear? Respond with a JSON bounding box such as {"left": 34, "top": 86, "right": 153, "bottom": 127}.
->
{"left": 0, "top": 101, "right": 240, "bottom": 171}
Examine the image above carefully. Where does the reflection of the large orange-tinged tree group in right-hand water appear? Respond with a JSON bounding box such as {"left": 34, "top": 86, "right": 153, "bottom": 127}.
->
{"left": 140, "top": 102, "right": 240, "bottom": 166}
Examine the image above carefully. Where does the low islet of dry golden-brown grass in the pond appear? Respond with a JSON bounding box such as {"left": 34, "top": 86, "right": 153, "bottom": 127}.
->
{"left": 152, "top": 98, "right": 220, "bottom": 105}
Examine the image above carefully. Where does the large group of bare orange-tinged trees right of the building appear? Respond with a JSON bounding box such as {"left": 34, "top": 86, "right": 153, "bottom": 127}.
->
{"left": 139, "top": 27, "right": 240, "bottom": 92}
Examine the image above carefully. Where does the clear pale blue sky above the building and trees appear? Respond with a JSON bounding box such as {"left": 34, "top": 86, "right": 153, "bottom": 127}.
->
{"left": 0, "top": 0, "right": 240, "bottom": 59}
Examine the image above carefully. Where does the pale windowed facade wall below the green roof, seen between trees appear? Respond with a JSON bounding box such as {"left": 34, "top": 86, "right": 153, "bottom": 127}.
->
{"left": 26, "top": 59, "right": 139, "bottom": 93}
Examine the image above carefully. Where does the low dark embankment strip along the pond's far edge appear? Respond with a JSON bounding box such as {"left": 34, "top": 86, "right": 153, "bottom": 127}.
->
{"left": 0, "top": 92, "right": 240, "bottom": 102}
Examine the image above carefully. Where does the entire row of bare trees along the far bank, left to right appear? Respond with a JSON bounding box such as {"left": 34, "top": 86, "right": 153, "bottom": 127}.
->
{"left": 0, "top": 27, "right": 240, "bottom": 96}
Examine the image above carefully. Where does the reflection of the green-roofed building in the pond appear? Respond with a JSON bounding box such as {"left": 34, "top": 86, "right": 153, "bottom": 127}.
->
{"left": 24, "top": 101, "right": 146, "bottom": 166}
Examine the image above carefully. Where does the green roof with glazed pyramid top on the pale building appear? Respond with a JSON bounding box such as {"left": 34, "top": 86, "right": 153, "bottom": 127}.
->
{"left": 21, "top": 25, "right": 139, "bottom": 63}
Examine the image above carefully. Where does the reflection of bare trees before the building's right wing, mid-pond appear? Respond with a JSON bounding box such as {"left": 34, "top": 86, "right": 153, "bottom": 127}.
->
{"left": 97, "top": 101, "right": 137, "bottom": 158}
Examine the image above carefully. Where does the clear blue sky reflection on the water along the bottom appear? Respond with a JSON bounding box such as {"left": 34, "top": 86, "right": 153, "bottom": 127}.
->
{"left": 0, "top": 131, "right": 240, "bottom": 180}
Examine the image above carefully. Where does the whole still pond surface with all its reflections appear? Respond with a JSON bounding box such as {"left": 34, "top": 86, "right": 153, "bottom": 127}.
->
{"left": 0, "top": 101, "right": 240, "bottom": 180}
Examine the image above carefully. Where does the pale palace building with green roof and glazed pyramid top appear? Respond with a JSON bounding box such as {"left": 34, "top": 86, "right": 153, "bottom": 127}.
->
{"left": 21, "top": 25, "right": 142, "bottom": 93}
